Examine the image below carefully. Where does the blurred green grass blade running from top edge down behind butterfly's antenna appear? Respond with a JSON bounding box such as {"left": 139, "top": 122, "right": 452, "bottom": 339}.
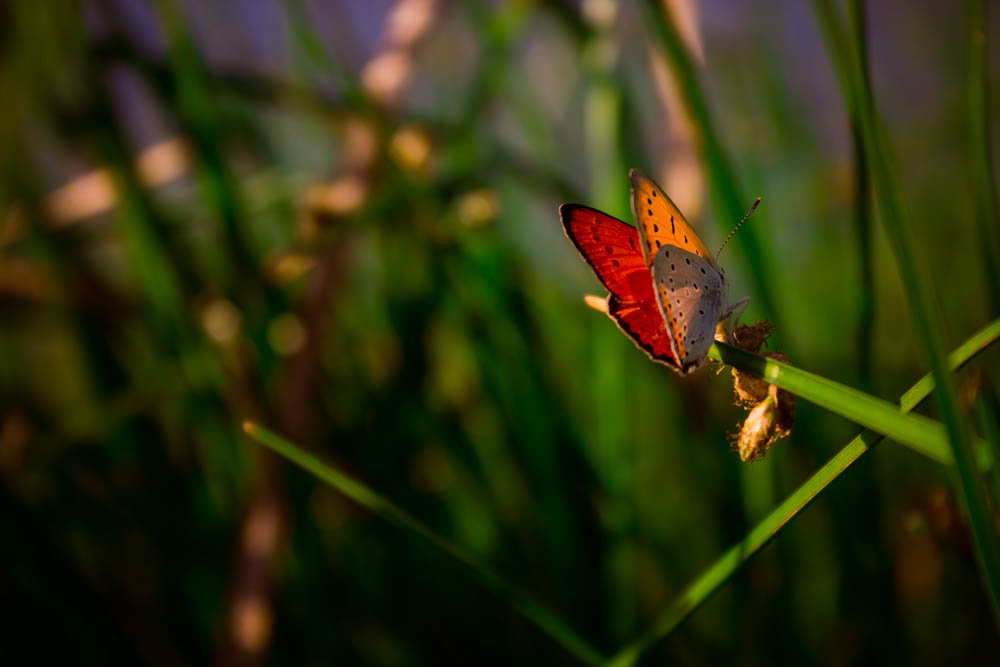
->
{"left": 643, "top": 0, "right": 781, "bottom": 331}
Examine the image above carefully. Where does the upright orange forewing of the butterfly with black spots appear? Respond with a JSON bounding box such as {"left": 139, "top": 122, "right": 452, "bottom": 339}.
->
{"left": 628, "top": 169, "right": 715, "bottom": 266}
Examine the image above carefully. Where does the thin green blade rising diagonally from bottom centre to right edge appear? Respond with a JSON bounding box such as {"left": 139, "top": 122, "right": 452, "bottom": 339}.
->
{"left": 609, "top": 320, "right": 1000, "bottom": 667}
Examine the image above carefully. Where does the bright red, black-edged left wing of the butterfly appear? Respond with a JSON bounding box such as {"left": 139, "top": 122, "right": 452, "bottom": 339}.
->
{"left": 559, "top": 204, "right": 677, "bottom": 367}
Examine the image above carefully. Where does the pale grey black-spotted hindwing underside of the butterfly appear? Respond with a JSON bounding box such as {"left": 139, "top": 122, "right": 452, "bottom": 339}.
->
{"left": 653, "top": 246, "right": 729, "bottom": 373}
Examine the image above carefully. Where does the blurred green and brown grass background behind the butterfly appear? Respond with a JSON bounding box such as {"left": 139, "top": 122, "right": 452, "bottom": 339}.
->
{"left": 0, "top": 0, "right": 1000, "bottom": 665}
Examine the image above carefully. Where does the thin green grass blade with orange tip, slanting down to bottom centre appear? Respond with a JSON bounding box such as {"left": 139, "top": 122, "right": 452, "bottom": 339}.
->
{"left": 243, "top": 422, "right": 603, "bottom": 665}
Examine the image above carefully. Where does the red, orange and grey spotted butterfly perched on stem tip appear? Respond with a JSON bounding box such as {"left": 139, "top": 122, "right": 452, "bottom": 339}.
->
{"left": 559, "top": 169, "right": 756, "bottom": 374}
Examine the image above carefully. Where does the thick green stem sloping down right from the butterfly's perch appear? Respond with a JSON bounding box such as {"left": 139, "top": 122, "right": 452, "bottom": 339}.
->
{"left": 708, "top": 343, "right": 953, "bottom": 463}
